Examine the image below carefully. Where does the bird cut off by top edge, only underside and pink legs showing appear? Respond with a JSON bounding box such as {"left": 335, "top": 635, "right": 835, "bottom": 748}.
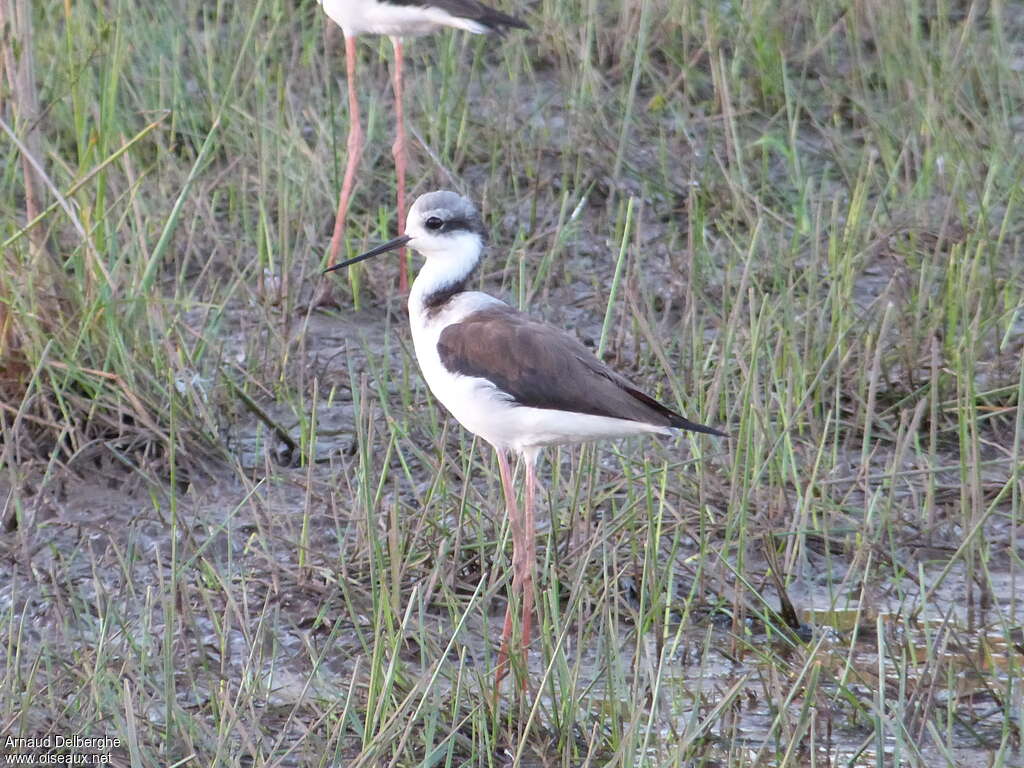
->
{"left": 314, "top": 0, "right": 526, "bottom": 304}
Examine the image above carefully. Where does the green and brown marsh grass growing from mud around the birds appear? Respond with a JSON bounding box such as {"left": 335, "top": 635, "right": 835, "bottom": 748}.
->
{"left": 0, "top": 0, "right": 1024, "bottom": 767}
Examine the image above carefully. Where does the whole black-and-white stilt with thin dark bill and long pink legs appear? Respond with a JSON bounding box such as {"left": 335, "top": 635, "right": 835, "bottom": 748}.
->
{"left": 327, "top": 191, "right": 725, "bottom": 685}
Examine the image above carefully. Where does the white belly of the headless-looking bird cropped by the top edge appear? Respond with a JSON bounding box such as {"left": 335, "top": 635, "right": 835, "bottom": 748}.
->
{"left": 321, "top": 0, "right": 486, "bottom": 37}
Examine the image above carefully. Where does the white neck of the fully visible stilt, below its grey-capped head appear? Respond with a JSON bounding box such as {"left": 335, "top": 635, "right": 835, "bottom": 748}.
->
{"left": 409, "top": 232, "right": 483, "bottom": 317}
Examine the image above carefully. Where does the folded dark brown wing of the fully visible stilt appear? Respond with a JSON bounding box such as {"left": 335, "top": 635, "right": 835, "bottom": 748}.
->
{"left": 437, "top": 307, "right": 723, "bottom": 435}
